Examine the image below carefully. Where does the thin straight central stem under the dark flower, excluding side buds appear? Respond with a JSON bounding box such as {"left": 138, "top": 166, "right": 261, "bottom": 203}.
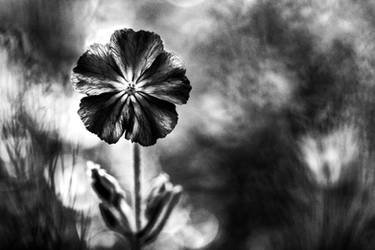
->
{"left": 133, "top": 143, "right": 141, "bottom": 250}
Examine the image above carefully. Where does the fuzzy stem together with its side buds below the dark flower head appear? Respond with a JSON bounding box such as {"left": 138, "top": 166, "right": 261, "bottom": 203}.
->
{"left": 87, "top": 159, "right": 182, "bottom": 250}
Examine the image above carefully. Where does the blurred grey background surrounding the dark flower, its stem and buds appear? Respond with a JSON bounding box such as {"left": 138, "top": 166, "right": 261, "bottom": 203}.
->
{"left": 0, "top": 0, "right": 375, "bottom": 250}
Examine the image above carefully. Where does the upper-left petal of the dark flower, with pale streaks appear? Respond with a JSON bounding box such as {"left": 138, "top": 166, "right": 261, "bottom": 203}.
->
{"left": 72, "top": 44, "right": 124, "bottom": 95}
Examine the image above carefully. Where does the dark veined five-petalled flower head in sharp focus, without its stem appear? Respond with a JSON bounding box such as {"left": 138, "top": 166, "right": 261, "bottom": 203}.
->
{"left": 72, "top": 29, "right": 191, "bottom": 146}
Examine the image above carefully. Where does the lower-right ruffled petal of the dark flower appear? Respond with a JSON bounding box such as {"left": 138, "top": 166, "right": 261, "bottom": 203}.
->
{"left": 125, "top": 93, "right": 178, "bottom": 146}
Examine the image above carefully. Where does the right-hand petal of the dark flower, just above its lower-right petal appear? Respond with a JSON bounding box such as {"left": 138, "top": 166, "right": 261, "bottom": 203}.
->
{"left": 138, "top": 52, "right": 191, "bottom": 104}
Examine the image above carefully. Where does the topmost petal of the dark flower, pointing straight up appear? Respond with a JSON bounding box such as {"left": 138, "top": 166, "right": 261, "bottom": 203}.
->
{"left": 110, "top": 29, "right": 164, "bottom": 82}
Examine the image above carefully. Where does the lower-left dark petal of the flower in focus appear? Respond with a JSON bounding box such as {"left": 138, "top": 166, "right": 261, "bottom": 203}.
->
{"left": 78, "top": 92, "right": 128, "bottom": 143}
